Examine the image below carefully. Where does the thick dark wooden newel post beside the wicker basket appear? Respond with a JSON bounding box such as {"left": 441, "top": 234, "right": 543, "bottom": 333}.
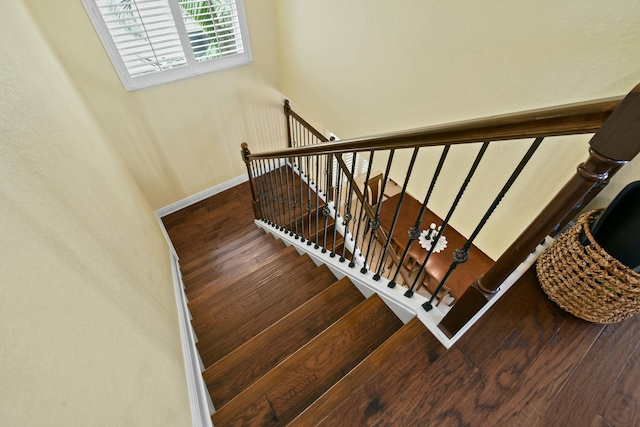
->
{"left": 438, "top": 85, "right": 640, "bottom": 338}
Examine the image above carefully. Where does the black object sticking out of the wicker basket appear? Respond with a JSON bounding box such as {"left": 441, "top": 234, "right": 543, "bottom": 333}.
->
{"left": 591, "top": 181, "right": 640, "bottom": 273}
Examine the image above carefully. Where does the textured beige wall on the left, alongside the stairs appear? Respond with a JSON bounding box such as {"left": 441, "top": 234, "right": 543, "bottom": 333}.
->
{"left": 0, "top": 0, "right": 191, "bottom": 426}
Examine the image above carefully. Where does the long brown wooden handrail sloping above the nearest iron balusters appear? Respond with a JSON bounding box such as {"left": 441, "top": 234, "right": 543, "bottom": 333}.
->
{"left": 248, "top": 97, "right": 624, "bottom": 160}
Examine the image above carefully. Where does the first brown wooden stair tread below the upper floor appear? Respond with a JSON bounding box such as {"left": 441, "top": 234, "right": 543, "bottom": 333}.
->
{"left": 212, "top": 295, "right": 402, "bottom": 426}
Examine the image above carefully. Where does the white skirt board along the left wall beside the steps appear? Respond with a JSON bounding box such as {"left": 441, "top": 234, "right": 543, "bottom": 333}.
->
{"left": 171, "top": 254, "right": 214, "bottom": 427}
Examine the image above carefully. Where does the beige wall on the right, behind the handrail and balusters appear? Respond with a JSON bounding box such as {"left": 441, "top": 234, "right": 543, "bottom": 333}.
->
{"left": 276, "top": 0, "right": 640, "bottom": 258}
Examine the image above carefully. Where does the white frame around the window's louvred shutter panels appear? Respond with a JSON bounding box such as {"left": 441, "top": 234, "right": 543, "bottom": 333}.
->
{"left": 82, "top": 0, "right": 253, "bottom": 91}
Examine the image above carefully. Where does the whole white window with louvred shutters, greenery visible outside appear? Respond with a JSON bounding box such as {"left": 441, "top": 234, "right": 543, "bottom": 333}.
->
{"left": 82, "top": 0, "right": 251, "bottom": 90}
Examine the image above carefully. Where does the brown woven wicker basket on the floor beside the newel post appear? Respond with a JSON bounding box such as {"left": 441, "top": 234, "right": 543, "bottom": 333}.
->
{"left": 536, "top": 209, "right": 640, "bottom": 323}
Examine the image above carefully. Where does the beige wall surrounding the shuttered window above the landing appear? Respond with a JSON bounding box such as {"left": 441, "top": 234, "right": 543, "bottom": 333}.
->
{"left": 24, "top": 0, "right": 286, "bottom": 209}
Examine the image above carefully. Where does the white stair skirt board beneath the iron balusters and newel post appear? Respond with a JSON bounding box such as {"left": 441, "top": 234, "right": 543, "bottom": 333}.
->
{"left": 255, "top": 220, "right": 552, "bottom": 349}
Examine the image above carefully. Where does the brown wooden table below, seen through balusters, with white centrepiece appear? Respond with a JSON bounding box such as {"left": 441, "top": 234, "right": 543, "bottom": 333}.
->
{"left": 380, "top": 194, "right": 493, "bottom": 298}
